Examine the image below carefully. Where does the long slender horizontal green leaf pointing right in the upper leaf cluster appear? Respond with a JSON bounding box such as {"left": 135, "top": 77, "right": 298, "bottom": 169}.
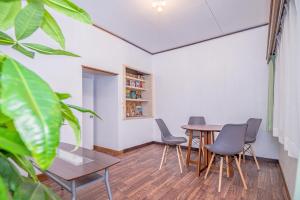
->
{"left": 22, "top": 43, "right": 79, "bottom": 57}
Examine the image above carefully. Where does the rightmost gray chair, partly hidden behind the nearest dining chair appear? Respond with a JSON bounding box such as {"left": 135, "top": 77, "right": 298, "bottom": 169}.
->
{"left": 239, "top": 118, "right": 262, "bottom": 170}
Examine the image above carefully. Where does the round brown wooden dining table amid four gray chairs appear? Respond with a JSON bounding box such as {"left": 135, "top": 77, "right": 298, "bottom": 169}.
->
{"left": 181, "top": 124, "right": 233, "bottom": 176}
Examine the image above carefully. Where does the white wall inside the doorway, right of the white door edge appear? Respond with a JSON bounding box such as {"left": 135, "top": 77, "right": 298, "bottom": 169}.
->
{"left": 94, "top": 75, "right": 119, "bottom": 149}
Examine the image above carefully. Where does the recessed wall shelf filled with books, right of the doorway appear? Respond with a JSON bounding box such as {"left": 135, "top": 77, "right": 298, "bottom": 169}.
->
{"left": 124, "top": 65, "right": 152, "bottom": 119}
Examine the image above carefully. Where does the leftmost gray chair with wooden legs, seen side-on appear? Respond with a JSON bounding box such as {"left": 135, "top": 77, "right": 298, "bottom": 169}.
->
{"left": 155, "top": 119, "right": 187, "bottom": 173}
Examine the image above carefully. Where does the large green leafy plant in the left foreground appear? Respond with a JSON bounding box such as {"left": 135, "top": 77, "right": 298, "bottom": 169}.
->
{"left": 0, "top": 0, "right": 96, "bottom": 200}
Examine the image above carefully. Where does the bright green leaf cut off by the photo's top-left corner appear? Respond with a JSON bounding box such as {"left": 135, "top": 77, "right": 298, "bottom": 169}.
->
{"left": 0, "top": 0, "right": 22, "bottom": 30}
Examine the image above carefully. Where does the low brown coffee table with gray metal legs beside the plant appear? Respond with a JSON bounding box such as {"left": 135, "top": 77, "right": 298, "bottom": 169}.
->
{"left": 34, "top": 143, "right": 120, "bottom": 200}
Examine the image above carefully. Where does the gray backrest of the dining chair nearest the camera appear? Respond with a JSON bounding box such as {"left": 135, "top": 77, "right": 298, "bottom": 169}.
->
{"left": 214, "top": 124, "right": 247, "bottom": 153}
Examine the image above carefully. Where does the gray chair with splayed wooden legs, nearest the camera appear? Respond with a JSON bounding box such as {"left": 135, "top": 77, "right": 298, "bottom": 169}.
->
{"left": 204, "top": 124, "right": 247, "bottom": 192}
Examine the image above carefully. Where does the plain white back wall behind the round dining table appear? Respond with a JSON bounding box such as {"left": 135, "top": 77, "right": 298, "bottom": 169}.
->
{"left": 152, "top": 26, "right": 278, "bottom": 158}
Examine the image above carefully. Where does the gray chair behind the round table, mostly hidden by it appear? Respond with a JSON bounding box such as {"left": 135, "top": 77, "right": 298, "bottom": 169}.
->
{"left": 185, "top": 116, "right": 206, "bottom": 157}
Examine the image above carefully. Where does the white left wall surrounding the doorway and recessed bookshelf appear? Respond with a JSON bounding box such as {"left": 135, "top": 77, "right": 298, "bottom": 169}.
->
{"left": 0, "top": 10, "right": 153, "bottom": 149}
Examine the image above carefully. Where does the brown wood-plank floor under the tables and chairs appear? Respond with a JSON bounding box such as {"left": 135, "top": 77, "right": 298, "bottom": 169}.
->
{"left": 44, "top": 144, "right": 288, "bottom": 200}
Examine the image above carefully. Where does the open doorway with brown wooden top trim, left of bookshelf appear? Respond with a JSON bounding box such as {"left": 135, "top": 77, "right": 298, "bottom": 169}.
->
{"left": 82, "top": 66, "right": 118, "bottom": 149}
